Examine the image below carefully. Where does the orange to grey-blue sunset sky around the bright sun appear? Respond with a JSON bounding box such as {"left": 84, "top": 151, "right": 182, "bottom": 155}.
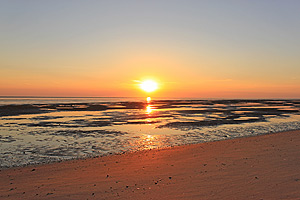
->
{"left": 0, "top": 0, "right": 300, "bottom": 98}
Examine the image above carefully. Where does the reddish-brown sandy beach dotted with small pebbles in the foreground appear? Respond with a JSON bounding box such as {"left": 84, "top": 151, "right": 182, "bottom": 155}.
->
{"left": 0, "top": 131, "right": 300, "bottom": 200}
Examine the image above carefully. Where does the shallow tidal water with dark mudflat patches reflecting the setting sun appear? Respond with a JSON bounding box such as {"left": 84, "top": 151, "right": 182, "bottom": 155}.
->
{"left": 0, "top": 98, "right": 300, "bottom": 167}
